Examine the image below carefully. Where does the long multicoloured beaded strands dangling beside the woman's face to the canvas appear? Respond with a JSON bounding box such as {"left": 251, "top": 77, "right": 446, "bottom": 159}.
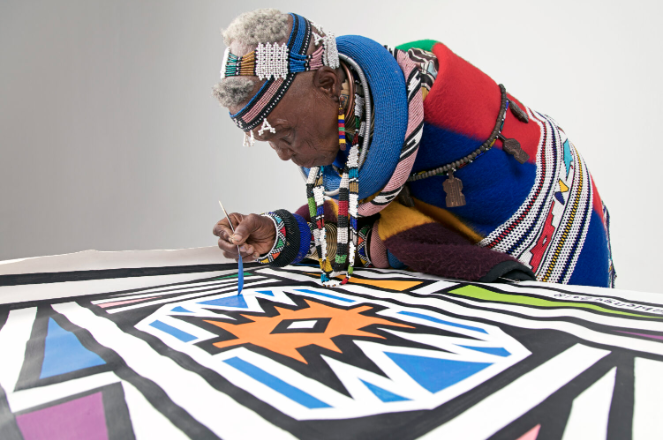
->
{"left": 306, "top": 63, "right": 367, "bottom": 287}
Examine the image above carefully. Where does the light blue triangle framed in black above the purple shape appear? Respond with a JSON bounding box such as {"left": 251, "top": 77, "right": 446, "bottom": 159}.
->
{"left": 39, "top": 318, "right": 106, "bottom": 379}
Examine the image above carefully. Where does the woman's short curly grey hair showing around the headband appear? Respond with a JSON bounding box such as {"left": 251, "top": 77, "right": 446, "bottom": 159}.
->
{"left": 212, "top": 9, "right": 290, "bottom": 107}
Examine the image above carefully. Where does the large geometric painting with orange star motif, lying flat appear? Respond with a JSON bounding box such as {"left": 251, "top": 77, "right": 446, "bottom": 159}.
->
{"left": 0, "top": 265, "right": 663, "bottom": 440}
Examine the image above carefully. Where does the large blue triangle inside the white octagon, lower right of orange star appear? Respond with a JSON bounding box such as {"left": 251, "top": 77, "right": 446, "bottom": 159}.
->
{"left": 385, "top": 353, "right": 492, "bottom": 393}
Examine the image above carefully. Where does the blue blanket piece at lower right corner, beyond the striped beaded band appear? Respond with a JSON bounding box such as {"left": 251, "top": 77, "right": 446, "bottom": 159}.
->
{"left": 569, "top": 211, "right": 610, "bottom": 287}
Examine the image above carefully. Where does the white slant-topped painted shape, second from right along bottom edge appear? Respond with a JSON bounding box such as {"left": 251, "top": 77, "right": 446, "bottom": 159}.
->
{"left": 562, "top": 368, "right": 620, "bottom": 440}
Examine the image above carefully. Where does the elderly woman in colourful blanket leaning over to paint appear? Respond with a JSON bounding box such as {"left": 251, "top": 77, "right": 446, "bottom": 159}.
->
{"left": 214, "top": 9, "right": 614, "bottom": 287}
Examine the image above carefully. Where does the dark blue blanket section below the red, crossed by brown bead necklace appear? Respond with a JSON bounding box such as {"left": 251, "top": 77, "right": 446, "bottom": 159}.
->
{"left": 409, "top": 123, "right": 536, "bottom": 235}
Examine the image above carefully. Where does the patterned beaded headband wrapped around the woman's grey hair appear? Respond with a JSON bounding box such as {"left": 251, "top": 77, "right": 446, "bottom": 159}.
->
{"left": 226, "top": 13, "right": 339, "bottom": 135}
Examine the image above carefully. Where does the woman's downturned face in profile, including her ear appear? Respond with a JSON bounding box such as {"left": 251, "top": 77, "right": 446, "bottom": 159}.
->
{"left": 230, "top": 68, "right": 339, "bottom": 168}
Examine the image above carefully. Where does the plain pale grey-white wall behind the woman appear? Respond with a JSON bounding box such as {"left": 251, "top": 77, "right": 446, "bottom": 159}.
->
{"left": 0, "top": 0, "right": 663, "bottom": 292}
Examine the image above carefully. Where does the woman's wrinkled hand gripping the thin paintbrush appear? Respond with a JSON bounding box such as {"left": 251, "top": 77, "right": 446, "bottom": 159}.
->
{"left": 212, "top": 212, "right": 276, "bottom": 260}
